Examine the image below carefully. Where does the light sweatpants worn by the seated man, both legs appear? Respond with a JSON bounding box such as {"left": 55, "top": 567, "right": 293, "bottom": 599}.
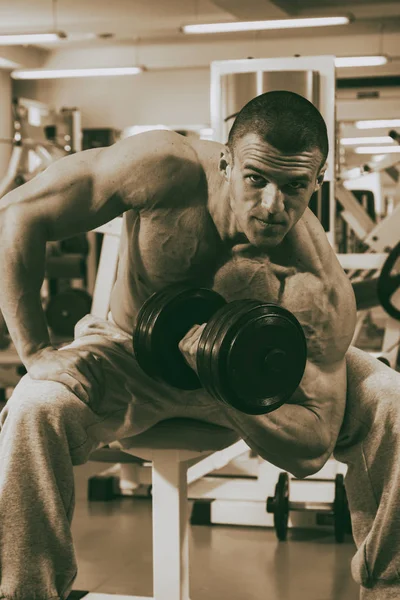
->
{"left": 0, "top": 316, "right": 400, "bottom": 600}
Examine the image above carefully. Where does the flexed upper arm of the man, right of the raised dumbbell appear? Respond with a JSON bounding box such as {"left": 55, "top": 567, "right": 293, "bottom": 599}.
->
{"left": 274, "top": 250, "right": 356, "bottom": 468}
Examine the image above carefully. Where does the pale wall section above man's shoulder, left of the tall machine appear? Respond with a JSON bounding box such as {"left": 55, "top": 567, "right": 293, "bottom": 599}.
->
{"left": 14, "top": 68, "right": 210, "bottom": 130}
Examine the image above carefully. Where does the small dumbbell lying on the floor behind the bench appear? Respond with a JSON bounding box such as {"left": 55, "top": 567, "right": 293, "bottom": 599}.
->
{"left": 266, "top": 471, "right": 351, "bottom": 543}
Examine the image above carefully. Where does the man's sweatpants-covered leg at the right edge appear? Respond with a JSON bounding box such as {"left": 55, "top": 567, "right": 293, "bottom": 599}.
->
{"left": 335, "top": 348, "right": 400, "bottom": 584}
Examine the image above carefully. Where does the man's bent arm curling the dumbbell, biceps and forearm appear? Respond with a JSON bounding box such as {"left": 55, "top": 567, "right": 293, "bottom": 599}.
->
{"left": 220, "top": 244, "right": 356, "bottom": 477}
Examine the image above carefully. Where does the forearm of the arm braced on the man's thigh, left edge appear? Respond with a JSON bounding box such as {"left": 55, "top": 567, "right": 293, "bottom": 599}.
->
{"left": 0, "top": 208, "right": 51, "bottom": 367}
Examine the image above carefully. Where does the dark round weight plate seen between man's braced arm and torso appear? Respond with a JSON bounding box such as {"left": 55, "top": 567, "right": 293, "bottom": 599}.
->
{"left": 46, "top": 288, "right": 92, "bottom": 337}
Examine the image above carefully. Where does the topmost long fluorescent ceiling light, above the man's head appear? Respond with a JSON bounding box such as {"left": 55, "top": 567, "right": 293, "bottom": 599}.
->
{"left": 182, "top": 17, "right": 350, "bottom": 33}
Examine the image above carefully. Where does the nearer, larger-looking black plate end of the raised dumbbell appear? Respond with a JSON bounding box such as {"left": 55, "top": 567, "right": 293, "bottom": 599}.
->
{"left": 197, "top": 300, "right": 307, "bottom": 414}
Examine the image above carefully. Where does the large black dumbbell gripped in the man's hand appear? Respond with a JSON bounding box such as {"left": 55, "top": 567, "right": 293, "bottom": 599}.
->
{"left": 133, "top": 285, "right": 307, "bottom": 414}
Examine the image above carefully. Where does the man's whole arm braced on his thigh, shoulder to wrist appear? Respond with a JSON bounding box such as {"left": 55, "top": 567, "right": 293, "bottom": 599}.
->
{"left": 0, "top": 132, "right": 200, "bottom": 371}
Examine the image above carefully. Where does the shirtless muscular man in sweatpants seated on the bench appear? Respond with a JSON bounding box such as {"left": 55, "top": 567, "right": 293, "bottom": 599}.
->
{"left": 0, "top": 92, "right": 400, "bottom": 600}
